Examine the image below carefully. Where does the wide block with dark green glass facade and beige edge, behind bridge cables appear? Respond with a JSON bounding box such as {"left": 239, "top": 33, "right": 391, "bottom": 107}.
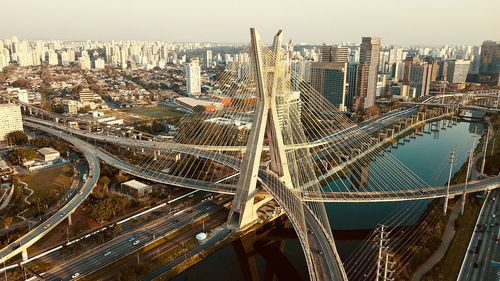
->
{"left": 311, "top": 62, "right": 347, "bottom": 110}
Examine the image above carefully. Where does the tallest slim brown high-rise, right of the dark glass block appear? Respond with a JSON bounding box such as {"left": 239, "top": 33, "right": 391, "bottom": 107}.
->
{"left": 354, "top": 37, "right": 380, "bottom": 114}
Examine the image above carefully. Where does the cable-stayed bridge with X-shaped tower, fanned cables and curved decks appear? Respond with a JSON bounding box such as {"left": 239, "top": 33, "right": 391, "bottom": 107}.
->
{"left": 0, "top": 29, "right": 499, "bottom": 280}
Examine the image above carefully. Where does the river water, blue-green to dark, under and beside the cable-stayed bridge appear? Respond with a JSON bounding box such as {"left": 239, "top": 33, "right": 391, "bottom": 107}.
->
{"left": 173, "top": 115, "right": 483, "bottom": 281}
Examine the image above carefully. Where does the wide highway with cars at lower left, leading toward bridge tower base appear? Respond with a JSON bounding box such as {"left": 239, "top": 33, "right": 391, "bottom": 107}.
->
{"left": 41, "top": 197, "right": 229, "bottom": 280}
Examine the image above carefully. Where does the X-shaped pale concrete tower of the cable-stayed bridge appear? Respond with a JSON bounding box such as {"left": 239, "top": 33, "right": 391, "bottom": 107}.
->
{"left": 228, "top": 28, "right": 293, "bottom": 228}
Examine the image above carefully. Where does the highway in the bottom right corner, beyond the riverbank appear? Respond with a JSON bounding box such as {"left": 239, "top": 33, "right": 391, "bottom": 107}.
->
{"left": 457, "top": 190, "right": 500, "bottom": 281}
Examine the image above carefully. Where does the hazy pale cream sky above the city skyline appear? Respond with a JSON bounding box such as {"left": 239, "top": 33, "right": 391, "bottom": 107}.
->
{"left": 0, "top": 0, "right": 500, "bottom": 45}
